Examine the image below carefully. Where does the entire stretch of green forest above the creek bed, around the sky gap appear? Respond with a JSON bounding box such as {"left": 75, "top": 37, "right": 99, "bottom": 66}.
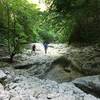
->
{"left": 0, "top": 0, "right": 100, "bottom": 61}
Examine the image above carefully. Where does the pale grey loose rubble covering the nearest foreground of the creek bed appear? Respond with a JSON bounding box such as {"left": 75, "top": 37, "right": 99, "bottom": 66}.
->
{"left": 0, "top": 69, "right": 99, "bottom": 100}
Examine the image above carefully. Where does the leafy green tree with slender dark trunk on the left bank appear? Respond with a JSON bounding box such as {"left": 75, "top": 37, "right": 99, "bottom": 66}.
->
{"left": 0, "top": 0, "right": 39, "bottom": 62}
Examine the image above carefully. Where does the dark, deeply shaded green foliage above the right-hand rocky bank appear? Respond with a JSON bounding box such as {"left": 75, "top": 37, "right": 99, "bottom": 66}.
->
{"left": 46, "top": 0, "right": 100, "bottom": 43}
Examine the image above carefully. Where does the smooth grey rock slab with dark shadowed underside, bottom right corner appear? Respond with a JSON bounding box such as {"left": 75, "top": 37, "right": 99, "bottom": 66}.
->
{"left": 73, "top": 75, "right": 100, "bottom": 97}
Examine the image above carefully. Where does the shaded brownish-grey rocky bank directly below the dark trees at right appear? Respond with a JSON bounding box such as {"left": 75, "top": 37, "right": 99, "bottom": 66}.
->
{"left": 66, "top": 45, "right": 100, "bottom": 75}
